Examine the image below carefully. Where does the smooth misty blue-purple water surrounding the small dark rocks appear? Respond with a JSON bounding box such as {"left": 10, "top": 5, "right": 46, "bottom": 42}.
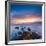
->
{"left": 10, "top": 23, "right": 42, "bottom": 39}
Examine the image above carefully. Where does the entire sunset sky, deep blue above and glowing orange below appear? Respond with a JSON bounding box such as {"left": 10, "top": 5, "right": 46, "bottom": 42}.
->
{"left": 10, "top": 3, "right": 42, "bottom": 24}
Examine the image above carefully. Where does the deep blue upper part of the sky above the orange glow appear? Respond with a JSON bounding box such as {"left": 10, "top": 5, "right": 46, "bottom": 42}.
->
{"left": 10, "top": 3, "right": 42, "bottom": 17}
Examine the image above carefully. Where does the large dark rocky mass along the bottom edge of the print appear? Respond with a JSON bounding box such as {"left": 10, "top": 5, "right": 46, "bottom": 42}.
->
{"left": 11, "top": 32, "right": 41, "bottom": 40}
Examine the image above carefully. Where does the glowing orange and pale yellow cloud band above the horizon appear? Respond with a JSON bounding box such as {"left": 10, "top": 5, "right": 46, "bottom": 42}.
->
{"left": 10, "top": 16, "right": 42, "bottom": 24}
